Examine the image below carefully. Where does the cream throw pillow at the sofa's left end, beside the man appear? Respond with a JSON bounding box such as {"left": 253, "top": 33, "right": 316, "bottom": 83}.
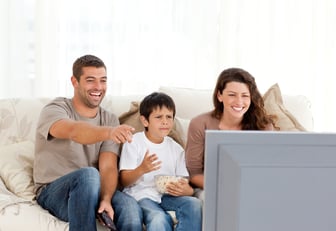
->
{"left": 0, "top": 141, "right": 35, "bottom": 200}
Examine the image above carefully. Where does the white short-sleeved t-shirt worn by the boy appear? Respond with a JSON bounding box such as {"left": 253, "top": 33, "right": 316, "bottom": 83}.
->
{"left": 119, "top": 132, "right": 189, "bottom": 203}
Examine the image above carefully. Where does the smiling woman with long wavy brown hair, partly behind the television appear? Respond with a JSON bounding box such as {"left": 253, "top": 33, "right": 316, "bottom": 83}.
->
{"left": 186, "top": 68, "right": 276, "bottom": 200}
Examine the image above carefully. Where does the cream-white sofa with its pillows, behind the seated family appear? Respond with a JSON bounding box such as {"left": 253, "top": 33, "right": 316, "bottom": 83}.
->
{"left": 0, "top": 84, "right": 313, "bottom": 231}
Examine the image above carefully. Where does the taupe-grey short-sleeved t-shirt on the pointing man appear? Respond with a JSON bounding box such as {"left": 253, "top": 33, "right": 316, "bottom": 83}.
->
{"left": 33, "top": 97, "right": 119, "bottom": 192}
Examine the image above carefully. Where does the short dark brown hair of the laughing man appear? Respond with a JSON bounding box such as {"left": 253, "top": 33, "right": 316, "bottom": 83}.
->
{"left": 72, "top": 55, "right": 106, "bottom": 82}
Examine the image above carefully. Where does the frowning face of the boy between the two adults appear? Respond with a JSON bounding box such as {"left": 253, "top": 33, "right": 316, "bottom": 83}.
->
{"left": 140, "top": 106, "right": 174, "bottom": 143}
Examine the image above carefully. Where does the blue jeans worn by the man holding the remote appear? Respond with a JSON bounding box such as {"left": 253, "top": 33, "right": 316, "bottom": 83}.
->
{"left": 37, "top": 167, "right": 142, "bottom": 231}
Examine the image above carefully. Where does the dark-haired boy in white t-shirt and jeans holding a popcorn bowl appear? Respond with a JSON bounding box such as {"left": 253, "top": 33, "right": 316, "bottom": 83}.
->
{"left": 120, "top": 92, "right": 202, "bottom": 231}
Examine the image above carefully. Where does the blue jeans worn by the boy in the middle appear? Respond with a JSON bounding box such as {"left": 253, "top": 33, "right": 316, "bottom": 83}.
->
{"left": 138, "top": 194, "right": 202, "bottom": 231}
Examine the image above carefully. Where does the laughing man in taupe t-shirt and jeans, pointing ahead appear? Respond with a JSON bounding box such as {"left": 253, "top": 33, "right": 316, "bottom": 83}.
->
{"left": 34, "top": 55, "right": 142, "bottom": 231}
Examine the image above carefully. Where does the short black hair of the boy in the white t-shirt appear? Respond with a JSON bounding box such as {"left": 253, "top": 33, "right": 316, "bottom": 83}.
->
{"left": 139, "top": 92, "right": 176, "bottom": 120}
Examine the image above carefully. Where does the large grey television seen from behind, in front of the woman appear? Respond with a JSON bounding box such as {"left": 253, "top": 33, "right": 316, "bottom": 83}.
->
{"left": 203, "top": 130, "right": 336, "bottom": 231}
